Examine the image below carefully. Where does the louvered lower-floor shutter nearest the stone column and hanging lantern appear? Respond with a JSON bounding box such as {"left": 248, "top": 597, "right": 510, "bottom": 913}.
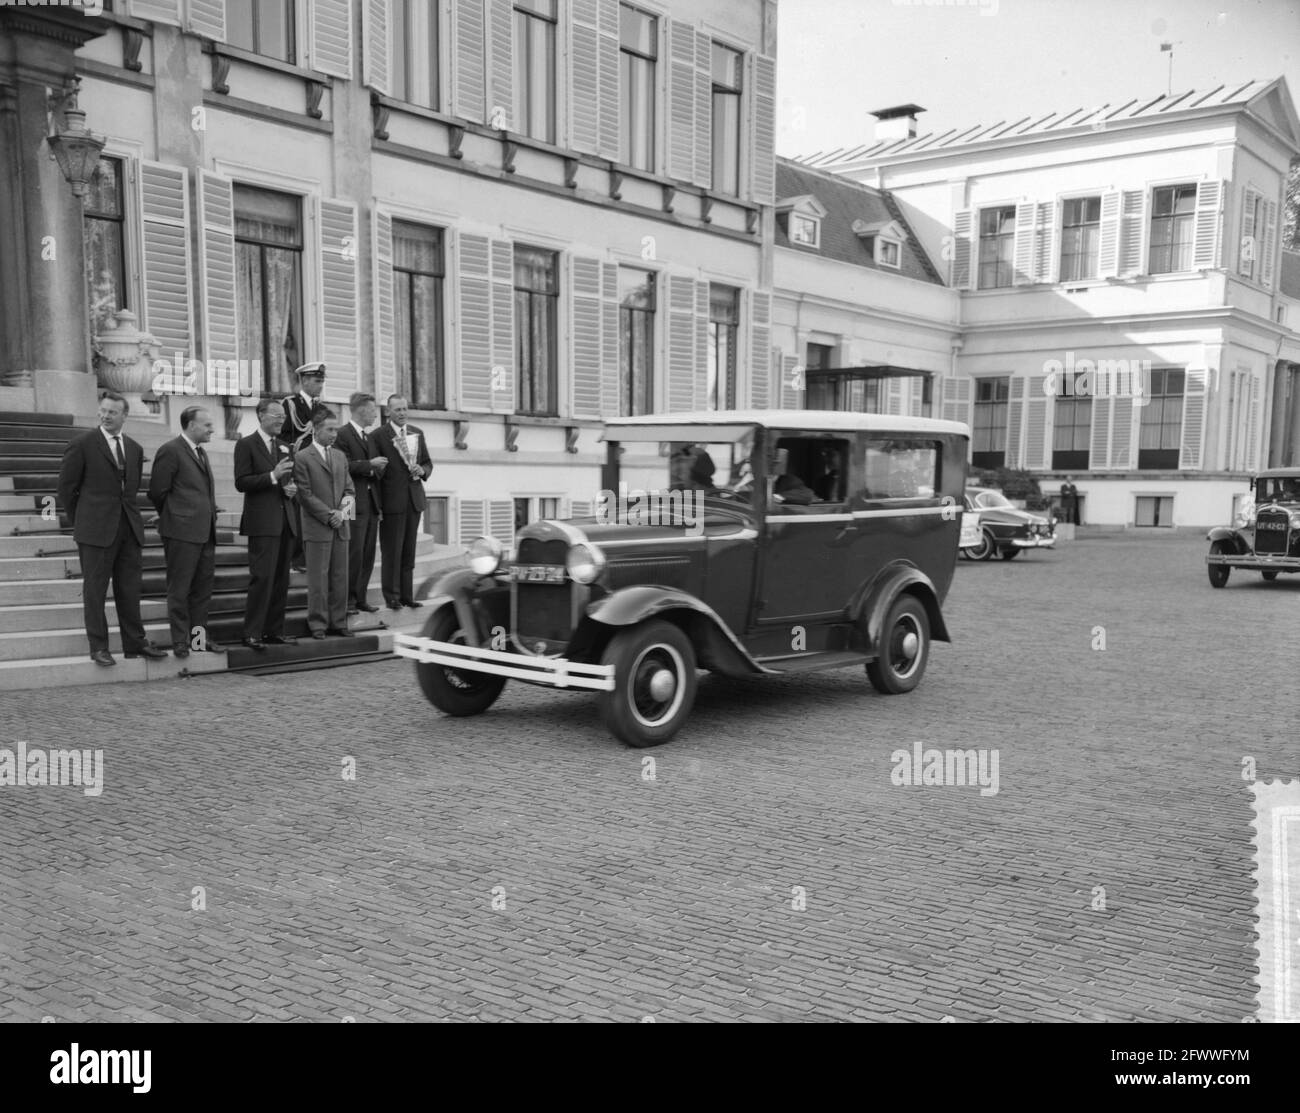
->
{"left": 140, "top": 163, "right": 194, "bottom": 363}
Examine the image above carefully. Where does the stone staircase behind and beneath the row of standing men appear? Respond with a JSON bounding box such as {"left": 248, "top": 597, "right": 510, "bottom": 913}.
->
{"left": 0, "top": 412, "right": 464, "bottom": 690}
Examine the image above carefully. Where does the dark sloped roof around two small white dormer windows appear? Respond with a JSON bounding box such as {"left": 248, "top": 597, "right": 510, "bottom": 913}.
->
{"left": 776, "top": 159, "right": 944, "bottom": 286}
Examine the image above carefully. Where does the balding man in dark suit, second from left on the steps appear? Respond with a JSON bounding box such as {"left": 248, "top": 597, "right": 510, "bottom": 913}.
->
{"left": 150, "top": 406, "right": 226, "bottom": 657}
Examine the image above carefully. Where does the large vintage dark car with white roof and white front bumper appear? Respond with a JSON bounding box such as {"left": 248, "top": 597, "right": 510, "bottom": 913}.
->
{"left": 394, "top": 411, "right": 969, "bottom": 746}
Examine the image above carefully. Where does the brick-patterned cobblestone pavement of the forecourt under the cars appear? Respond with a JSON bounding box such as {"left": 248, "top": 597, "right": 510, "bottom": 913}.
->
{"left": 0, "top": 537, "right": 1300, "bottom": 1022}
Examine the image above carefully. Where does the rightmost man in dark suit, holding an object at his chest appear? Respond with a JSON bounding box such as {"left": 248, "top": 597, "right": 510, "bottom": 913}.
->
{"left": 371, "top": 394, "right": 433, "bottom": 611}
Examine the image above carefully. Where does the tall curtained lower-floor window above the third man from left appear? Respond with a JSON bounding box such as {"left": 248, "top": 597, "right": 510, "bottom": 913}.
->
{"left": 234, "top": 185, "right": 303, "bottom": 393}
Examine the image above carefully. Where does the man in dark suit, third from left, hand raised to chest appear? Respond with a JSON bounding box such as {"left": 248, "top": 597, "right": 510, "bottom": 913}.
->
{"left": 235, "top": 398, "right": 298, "bottom": 649}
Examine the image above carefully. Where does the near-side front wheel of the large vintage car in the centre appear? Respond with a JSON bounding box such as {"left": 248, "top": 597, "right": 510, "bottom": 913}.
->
{"left": 599, "top": 620, "right": 696, "bottom": 748}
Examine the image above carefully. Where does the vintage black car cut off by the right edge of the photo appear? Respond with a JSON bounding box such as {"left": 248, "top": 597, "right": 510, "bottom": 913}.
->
{"left": 1205, "top": 468, "right": 1300, "bottom": 588}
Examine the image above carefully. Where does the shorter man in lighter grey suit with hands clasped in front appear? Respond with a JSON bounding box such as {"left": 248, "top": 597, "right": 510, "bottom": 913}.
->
{"left": 294, "top": 408, "right": 356, "bottom": 638}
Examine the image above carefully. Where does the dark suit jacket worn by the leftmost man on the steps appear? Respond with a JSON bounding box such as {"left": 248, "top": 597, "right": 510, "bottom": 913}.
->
{"left": 59, "top": 429, "right": 144, "bottom": 549}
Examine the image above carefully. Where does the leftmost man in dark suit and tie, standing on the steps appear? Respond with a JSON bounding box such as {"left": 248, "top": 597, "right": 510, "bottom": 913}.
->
{"left": 59, "top": 390, "right": 166, "bottom": 666}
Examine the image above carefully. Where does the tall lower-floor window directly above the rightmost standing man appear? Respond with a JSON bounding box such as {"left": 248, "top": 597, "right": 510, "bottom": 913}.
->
{"left": 393, "top": 220, "right": 447, "bottom": 410}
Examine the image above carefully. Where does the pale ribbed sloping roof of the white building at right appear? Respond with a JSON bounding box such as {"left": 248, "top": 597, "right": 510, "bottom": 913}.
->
{"left": 798, "top": 78, "right": 1300, "bottom": 166}
